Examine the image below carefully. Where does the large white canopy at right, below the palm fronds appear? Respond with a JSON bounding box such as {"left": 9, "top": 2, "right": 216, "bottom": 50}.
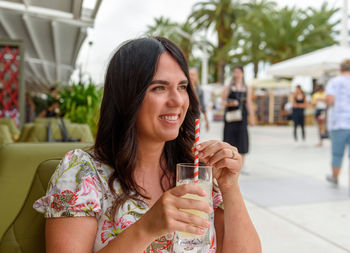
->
{"left": 267, "top": 45, "right": 350, "bottom": 78}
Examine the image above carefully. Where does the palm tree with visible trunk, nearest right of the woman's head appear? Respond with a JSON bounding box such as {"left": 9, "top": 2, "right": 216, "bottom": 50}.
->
{"left": 188, "top": 0, "right": 243, "bottom": 83}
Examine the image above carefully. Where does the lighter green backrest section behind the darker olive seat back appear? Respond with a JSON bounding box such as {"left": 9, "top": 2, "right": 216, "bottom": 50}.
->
{"left": 0, "top": 142, "right": 91, "bottom": 238}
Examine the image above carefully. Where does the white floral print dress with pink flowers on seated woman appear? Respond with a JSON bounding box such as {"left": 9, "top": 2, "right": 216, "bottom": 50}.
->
{"left": 34, "top": 149, "right": 223, "bottom": 253}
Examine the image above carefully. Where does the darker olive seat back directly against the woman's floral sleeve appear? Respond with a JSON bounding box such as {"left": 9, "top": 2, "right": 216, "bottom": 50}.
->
{"left": 0, "top": 159, "right": 60, "bottom": 253}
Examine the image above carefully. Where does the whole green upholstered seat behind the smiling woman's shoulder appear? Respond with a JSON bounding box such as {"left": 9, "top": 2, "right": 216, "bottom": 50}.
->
{"left": 0, "top": 143, "right": 91, "bottom": 253}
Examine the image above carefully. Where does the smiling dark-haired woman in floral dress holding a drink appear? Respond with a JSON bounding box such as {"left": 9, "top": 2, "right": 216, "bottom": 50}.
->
{"left": 34, "top": 37, "right": 261, "bottom": 253}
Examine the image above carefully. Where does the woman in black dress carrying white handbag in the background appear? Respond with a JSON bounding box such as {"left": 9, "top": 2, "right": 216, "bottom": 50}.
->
{"left": 222, "top": 66, "right": 255, "bottom": 174}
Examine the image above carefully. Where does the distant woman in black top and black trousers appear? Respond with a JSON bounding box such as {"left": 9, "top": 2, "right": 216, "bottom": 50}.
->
{"left": 292, "top": 85, "right": 307, "bottom": 141}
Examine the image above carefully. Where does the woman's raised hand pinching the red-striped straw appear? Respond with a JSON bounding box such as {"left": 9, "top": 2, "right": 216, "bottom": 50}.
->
{"left": 194, "top": 140, "right": 242, "bottom": 191}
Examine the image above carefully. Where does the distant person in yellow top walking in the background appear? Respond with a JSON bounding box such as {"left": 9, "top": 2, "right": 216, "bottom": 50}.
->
{"left": 311, "top": 85, "right": 327, "bottom": 147}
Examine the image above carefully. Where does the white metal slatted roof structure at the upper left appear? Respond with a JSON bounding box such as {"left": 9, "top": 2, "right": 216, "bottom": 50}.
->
{"left": 0, "top": 0, "right": 102, "bottom": 91}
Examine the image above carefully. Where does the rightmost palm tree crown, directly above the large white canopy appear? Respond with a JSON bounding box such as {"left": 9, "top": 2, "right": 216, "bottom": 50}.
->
{"left": 263, "top": 4, "right": 338, "bottom": 63}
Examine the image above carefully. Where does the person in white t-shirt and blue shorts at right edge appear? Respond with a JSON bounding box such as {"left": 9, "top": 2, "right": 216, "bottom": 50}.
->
{"left": 326, "top": 59, "right": 350, "bottom": 185}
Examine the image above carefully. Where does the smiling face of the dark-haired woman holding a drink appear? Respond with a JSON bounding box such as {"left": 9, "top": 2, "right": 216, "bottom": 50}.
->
{"left": 136, "top": 53, "right": 189, "bottom": 142}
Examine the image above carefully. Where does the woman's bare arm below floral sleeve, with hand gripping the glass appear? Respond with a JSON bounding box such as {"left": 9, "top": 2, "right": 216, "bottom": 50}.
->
{"left": 46, "top": 184, "right": 212, "bottom": 253}
